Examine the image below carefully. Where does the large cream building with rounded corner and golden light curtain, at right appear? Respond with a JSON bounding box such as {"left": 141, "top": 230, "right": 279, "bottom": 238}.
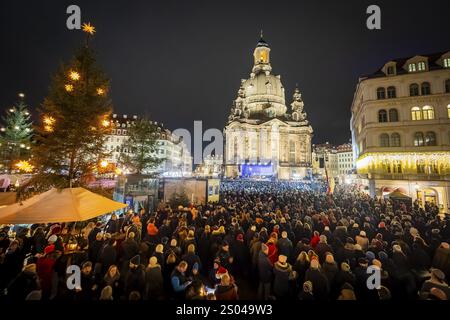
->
{"left": 351, "top": 52, "right": 450, "bottom": 212}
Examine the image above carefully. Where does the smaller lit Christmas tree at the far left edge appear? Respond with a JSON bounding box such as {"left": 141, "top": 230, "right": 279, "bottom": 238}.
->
{"left": 0, "top": 94, "right": 33, "bottom": 172}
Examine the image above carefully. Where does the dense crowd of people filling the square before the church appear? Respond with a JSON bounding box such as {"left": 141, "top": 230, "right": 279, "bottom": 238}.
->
{"left": 0, "top": 181, "right": 450, "bottom": 301}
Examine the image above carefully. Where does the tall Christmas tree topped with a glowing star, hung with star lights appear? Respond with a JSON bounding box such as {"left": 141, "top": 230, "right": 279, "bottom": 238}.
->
{"left": 26, "top": 25, "right": 112, "bottom": 190}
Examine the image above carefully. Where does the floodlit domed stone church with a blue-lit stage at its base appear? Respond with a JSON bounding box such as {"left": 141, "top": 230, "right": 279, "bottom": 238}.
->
{"left": 224, "top": 34, "right": 313, "bottom": 180}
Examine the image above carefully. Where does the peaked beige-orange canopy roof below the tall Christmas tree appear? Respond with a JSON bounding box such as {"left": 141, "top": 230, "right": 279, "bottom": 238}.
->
{"left": 0, "top": 188, "right": 127, "bottom": 224}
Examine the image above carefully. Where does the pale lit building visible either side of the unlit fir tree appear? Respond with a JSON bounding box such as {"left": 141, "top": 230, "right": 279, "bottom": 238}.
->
{"left": 105, "top": 114, "right": 192, "bottom": 177}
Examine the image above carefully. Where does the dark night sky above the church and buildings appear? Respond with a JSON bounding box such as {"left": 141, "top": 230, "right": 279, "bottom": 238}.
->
{"left": 0, "top": 0, "right": 450, "bottom": 143}
